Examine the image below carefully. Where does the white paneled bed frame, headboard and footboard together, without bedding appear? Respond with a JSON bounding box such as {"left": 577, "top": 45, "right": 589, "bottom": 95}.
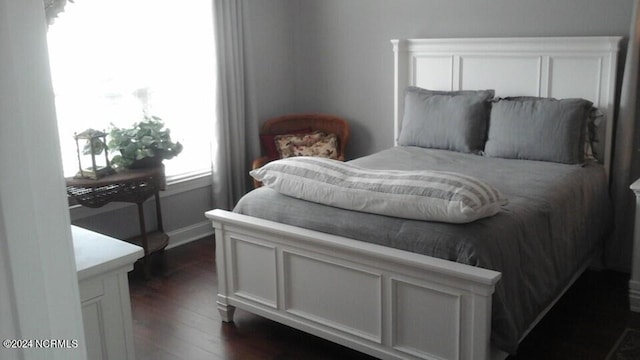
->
{"left": 206, "top": 37, "right": 620, "bottom": 360}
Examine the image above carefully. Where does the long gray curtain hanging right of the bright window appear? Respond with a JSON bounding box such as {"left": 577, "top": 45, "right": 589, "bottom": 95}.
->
{"left": 212, "top": 0, "right": 258, "bottom": 209}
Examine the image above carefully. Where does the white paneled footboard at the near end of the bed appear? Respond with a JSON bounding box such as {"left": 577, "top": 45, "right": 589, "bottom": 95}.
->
{"left": 206, "top": 210, "right": 500, "bottom": 359}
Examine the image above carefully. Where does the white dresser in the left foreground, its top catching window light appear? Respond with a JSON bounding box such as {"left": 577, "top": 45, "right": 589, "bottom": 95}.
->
{"left": 72, "top": 226, "right": 144, "bottom": 360}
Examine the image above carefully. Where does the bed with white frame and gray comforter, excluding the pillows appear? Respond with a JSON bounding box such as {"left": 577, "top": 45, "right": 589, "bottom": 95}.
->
{"left": 206, "top": 37, "right": 620, "bottom": 359}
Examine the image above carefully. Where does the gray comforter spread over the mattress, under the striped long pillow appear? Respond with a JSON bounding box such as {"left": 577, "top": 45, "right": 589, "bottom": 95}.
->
{"left": 234, "top": 147, "right": 611, "bottom": 353}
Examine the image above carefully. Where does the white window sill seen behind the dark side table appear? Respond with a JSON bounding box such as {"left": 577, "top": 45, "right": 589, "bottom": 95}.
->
{"left": 69, "top": 170, "right": 212, "bottom": 221}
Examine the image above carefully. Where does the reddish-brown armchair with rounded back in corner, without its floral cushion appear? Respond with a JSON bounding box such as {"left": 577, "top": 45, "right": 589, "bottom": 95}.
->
{"left": 251, "top": 114, "right": 350, "bottom": 187}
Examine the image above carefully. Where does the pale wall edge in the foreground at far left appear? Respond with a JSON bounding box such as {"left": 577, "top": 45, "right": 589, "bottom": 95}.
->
{"left": 0, "top": 0, "right": 86, "bottom": 359}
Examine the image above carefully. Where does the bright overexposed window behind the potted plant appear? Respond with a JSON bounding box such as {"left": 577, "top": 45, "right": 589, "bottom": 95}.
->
{"left": 48, "top": 0, "right": 216, "bottom": 180}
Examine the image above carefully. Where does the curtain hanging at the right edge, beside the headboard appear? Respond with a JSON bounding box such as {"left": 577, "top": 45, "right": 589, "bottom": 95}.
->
{"left": 605, "top": 0, "right": 640, "bottom": 271}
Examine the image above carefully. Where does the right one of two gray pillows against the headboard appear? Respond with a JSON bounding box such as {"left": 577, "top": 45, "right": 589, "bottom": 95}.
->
{"left": 484, "top": 97, "right": 592, "bottom": 164}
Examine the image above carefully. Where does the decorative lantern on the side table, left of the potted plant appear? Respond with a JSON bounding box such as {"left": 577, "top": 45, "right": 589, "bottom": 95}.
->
{"left": 73, "top": 129, "right": 114, "bottom": 180}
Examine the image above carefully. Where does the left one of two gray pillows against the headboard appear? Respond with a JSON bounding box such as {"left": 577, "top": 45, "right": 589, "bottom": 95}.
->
{"left": 398, "top": 86, "right": 494, "bottom": 153}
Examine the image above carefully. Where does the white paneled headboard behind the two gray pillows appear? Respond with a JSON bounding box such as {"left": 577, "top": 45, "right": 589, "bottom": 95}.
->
{"left": 391, "top": 36, "right": 622, "bottom": 173}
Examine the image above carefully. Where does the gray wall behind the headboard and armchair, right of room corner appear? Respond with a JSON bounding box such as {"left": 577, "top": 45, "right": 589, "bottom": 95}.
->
{"left": 286, "top": 0, "right": 633, "bottom": 157}
